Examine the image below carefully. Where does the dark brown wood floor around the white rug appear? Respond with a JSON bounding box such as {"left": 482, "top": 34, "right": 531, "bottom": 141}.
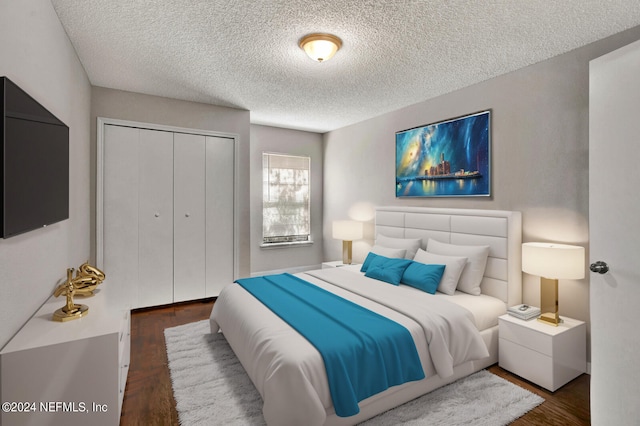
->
{"left": 120, "top": 300, "right": 590, "bottom": 426}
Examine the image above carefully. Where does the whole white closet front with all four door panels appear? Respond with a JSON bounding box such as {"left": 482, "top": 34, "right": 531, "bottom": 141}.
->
{"left": 102, "top": 124, "right": 235, "bottom": 308}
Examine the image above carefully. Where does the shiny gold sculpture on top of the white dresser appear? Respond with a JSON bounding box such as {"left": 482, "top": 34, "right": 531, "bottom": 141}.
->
{"left": 53, "top": 262, "right": 105, "bottom": 322}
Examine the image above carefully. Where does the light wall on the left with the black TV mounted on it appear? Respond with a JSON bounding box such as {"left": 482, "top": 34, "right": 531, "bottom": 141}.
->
{"left": 0, "top": 0, "right": 91, "bottom": 347}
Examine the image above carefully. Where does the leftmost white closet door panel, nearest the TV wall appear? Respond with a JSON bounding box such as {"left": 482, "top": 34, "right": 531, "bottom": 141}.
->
{"left": 99, "top": 125, "right": 139, "bottom": 306}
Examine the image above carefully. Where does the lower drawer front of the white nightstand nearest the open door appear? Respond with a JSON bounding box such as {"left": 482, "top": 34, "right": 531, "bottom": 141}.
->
{"left": 498, "top": 338, "right": 556, "bottom": 391}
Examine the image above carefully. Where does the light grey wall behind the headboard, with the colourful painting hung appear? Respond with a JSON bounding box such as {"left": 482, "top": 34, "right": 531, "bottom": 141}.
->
{"left": 324, "top": 27, "right": 640, "bottom": 358}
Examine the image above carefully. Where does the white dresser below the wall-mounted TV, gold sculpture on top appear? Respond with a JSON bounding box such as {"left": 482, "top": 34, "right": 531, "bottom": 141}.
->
{"left": 0, "top": 280, "right": 130, "bottom": 426}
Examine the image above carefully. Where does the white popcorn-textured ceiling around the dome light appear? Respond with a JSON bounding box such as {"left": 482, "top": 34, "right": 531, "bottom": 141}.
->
{"left": 52, "top": 0, "right": 640, "bottom": 132}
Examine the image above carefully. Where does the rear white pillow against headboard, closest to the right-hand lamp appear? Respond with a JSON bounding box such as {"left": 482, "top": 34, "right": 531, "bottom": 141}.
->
{"left": 427, "top": 238, "right": 489, "bottom": 296}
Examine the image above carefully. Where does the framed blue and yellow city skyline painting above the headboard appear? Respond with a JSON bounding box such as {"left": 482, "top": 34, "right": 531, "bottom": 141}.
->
{"left": 396, "top": 110, "right": 491, "bottom": 197}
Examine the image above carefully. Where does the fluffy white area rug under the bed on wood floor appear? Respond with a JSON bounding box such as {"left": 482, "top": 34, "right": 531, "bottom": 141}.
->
{"left": 164, "top": 320, "right": 544, "bottom": 426}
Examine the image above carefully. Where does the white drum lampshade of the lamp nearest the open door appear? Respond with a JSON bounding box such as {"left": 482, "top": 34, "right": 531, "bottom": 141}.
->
{"left": 522, "top": 243, "right": 585, "bottom": 280}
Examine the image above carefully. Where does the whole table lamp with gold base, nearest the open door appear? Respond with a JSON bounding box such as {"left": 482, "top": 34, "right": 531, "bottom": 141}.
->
{"left": 522, "top": 243, "right": 585, "bottom": 327}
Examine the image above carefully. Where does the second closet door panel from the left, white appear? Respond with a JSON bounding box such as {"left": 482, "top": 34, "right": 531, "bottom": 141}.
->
{"left": 138, "top": 129, "right": 173, "bottom": 307}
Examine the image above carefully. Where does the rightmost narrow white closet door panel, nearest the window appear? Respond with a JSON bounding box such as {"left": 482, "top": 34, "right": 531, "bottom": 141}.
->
{"left": 206, "top": 136, "right": 235, "bottom": 297}
